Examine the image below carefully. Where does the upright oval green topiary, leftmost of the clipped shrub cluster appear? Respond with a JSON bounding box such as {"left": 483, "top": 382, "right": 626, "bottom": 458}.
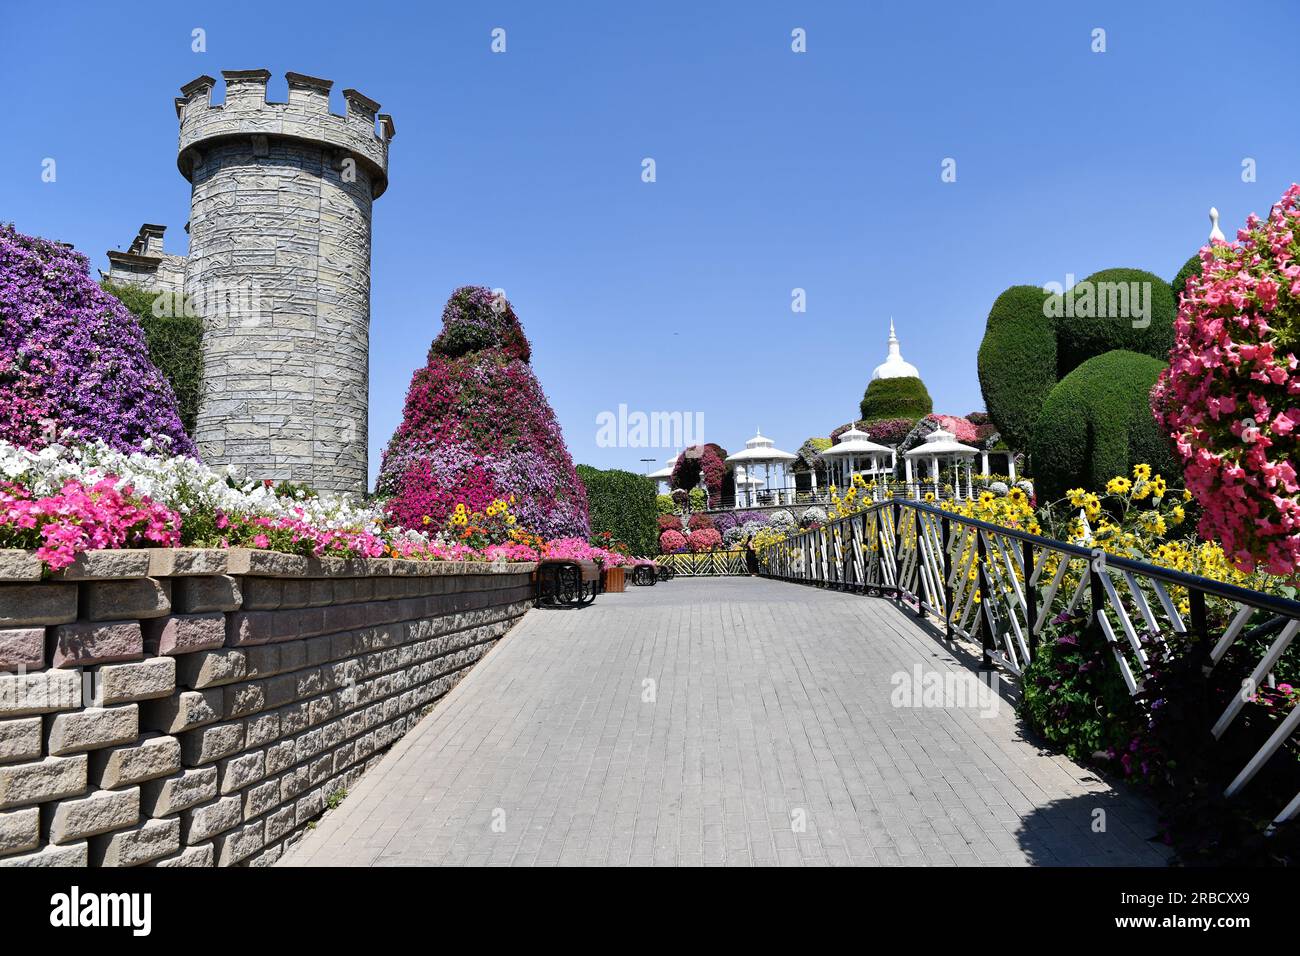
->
{"left": 978, "top": 285, "right": 1057, "bottom": 449}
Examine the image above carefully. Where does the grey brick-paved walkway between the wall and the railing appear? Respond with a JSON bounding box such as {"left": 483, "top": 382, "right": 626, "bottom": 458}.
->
{"left": 283, "top": 579, "right": 1164, "bottom": 866}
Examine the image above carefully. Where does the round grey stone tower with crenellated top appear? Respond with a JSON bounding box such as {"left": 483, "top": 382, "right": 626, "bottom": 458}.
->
{"left": 175, "top": 70, "right": 395, "bottom": 492}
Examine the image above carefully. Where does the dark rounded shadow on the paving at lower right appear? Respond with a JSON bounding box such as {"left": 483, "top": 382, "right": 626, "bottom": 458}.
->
{"left": 1015, "top": 778, "right": 1173, "bottom": 866}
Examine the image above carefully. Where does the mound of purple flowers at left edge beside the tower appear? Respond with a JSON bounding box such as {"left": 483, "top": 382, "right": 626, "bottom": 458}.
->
{"left": 0, "top": 225, "right": 195, "bottom": 455}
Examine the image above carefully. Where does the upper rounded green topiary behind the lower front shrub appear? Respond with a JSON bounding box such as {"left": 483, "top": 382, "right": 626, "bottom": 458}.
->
{"left": 1045, "top": 269, "right": 1178, "bottom": 380}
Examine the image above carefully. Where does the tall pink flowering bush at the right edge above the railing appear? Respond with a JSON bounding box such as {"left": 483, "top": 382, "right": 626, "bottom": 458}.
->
{"left": 1151, "top": 185, "right": 1300, "bottom": 579}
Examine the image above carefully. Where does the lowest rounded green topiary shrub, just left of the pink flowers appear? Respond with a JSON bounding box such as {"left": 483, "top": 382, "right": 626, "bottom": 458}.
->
{"left": 1030, "top": 349, "right": 1179, "bottom": 501}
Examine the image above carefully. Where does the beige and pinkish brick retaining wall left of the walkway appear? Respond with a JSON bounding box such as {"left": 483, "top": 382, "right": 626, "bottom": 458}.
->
{"left": 0, "top": 549, "right": 533, "bottom": 866}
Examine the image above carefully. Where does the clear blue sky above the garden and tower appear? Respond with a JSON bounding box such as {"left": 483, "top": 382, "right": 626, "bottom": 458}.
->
{"left": 0, "top": 0, "right": 1300, "bottom": 475}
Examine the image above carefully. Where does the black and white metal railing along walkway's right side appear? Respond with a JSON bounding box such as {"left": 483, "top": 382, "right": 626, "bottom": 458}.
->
{"left": 759, "top": 501, "right": 1300, "bottom": 825}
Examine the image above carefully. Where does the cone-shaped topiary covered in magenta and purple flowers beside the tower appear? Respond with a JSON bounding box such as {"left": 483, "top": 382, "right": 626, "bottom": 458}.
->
{"left": 377, "top": 286, "right": 589, "bottom": 538}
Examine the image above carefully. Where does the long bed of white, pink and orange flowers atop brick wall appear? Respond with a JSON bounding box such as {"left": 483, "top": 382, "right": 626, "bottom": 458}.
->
{"left": 0, "top": 441, "right": 644, "bottom": 571}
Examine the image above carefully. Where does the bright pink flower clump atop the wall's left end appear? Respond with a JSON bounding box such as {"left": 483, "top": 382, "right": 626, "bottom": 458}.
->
{"left": 0, "top": 477, "right": 181, "bottom": 571}
